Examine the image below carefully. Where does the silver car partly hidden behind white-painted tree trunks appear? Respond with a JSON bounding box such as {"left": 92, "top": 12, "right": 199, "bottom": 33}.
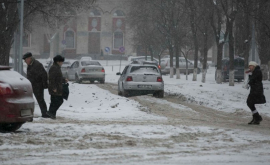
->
{"left": 160, "top": 57, "right": 201, "bottom": 74}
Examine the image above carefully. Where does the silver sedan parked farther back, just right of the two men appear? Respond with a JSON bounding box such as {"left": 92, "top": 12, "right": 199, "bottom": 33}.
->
{"left": 66, "top": 59, "right": 105, "bottom": 84}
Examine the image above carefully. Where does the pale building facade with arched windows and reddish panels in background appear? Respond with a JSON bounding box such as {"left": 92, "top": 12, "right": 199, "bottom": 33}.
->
{"left": 10, "top": 0, "right": 135, "bottom": 59}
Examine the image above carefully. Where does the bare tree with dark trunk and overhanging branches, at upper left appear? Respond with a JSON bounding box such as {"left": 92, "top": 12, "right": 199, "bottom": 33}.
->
{"left": 0, "top": 0, "right": 95, "bottom": 65}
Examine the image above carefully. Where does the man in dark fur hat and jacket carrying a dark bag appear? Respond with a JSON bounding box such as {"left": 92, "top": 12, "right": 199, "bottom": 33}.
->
{"left": 47, "top": 55, "right": 67, "bottom": 119}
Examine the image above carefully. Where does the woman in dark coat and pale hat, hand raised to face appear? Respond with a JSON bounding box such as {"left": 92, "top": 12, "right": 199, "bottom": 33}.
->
{"left": 247, "top": 61, "right": 266, "bottom": 125}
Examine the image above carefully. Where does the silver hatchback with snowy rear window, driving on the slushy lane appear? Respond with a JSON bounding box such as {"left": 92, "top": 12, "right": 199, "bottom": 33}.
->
{"left": 116, "top": 64, "right": 164, "bottom": 98}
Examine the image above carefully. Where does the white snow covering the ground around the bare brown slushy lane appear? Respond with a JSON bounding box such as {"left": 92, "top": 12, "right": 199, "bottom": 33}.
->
{"left": 0, "top": 60, "right": 270, "bottom": 165}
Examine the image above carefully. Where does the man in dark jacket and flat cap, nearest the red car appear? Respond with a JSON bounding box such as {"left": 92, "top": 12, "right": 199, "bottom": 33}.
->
{"left": 23, "top": 52, "right": 49, "bottom": 118}
